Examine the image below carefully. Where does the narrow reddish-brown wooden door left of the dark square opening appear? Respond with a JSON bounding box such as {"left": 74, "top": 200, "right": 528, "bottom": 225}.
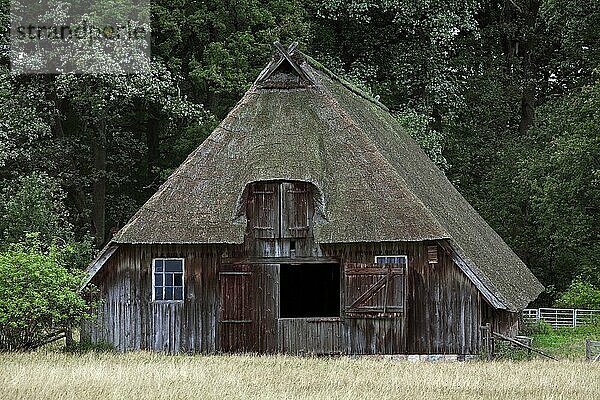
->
{"left": 218, "top": 266, "right": 257, "bottom": 353}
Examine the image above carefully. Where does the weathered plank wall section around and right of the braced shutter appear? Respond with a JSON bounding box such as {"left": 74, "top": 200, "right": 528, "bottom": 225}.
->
{"left": 323, "top": 242, "right": 482, "bottom": 354}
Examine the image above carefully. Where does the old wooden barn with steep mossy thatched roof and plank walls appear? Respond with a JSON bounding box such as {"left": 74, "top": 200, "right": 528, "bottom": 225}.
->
{"left": 83, "top": 45, "right": 542, "bottom": 354}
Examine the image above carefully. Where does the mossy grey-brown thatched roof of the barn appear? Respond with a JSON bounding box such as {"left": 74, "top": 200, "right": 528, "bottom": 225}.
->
{"left": 104, "top": 46, "right": 542, "bottom": 310}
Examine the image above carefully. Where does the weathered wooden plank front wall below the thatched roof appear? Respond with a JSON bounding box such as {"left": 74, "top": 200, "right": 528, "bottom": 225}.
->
{"left": 82, "top": 239, "right": 516, "bottom": 354}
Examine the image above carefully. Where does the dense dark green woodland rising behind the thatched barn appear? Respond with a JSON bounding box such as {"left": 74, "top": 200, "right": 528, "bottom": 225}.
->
{"left": 0, "top": 0, "right": 600, "bottom": 304}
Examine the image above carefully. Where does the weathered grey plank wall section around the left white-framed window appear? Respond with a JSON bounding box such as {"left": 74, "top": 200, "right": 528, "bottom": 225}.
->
{"left": 82, "top": 245, "right": 222, "bottom": 353}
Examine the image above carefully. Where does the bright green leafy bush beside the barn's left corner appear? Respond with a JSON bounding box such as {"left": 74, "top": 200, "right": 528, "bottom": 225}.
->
{"left": 0, "top": 244, "right": 88, "bottom": 351}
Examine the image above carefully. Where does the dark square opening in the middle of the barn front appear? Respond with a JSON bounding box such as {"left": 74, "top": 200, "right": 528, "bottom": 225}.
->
{"left": 279, "top": 264, "right": 340, "bottom": 318}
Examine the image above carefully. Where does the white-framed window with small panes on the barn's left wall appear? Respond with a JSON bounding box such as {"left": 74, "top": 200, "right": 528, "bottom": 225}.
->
{"left": 152, "top": 258, "right": 183, "bottom": 301}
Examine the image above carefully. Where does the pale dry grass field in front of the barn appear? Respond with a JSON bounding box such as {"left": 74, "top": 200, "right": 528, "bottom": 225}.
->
{"left": 0, "top": 352, "right": 600, "bottom": 400}
